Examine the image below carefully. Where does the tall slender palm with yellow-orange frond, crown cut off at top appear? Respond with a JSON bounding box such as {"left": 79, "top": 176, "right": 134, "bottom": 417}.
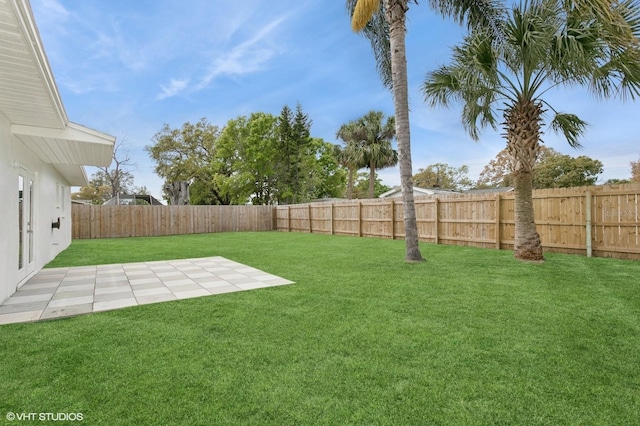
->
{"left": 347, "top": 0, "right": 504, "bottom": 262}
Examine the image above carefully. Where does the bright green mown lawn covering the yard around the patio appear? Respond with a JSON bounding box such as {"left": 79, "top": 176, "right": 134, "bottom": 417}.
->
{"left": 0, "top": 232, "right": 640, "bottom": 426}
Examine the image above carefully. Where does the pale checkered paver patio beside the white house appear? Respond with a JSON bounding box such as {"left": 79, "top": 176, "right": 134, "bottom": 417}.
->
{"left": 0, "top": 256, "right": 293, "bottom": 324}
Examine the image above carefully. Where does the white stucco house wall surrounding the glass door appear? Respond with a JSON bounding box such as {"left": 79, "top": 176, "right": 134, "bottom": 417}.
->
{"left": 0, "top": 112, "right": 71, "bottom": 303}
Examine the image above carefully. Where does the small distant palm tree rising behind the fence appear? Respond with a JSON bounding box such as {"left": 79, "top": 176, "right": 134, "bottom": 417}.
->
{"left": 337, "top": 111, "right": 398, "bottom": 198}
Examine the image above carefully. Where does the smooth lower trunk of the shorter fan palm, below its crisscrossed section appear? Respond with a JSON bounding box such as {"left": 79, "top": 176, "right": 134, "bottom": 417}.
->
{"left": 513, "top": 172, "right": 543, "bottom": 260}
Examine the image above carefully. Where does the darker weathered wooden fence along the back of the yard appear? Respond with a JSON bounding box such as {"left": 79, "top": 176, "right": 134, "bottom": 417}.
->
{"left": 71, "top": 204, "right": 274, "bottom": 238}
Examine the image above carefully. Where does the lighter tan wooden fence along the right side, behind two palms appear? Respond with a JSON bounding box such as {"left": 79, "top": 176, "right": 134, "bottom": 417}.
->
{"left": 276, "top": 184, "right": 640, "bottom": 259}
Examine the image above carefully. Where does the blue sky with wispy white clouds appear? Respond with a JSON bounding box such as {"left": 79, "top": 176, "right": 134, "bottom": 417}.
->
{"left": 31, "top": 0, "right": 640, "bottom": 196}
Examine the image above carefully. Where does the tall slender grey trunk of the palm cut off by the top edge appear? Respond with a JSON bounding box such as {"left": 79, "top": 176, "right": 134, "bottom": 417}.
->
{"left": 385, "top": 0, "right": 424, "bottom": 262}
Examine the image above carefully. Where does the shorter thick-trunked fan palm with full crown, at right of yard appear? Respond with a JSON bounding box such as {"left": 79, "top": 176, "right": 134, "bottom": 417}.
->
{"left": 423, "top": 0, "right": 640, "bottom": 260}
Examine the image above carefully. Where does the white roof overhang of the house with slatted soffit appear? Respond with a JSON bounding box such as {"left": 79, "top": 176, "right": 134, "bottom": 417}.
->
{"left": 0, "top": 0, "right": 116, "bottom": 186}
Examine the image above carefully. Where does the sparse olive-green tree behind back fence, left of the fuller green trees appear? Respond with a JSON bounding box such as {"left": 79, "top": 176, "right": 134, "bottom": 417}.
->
{"left": 145, "top": 118, "right": 222, "bottom": 204}
